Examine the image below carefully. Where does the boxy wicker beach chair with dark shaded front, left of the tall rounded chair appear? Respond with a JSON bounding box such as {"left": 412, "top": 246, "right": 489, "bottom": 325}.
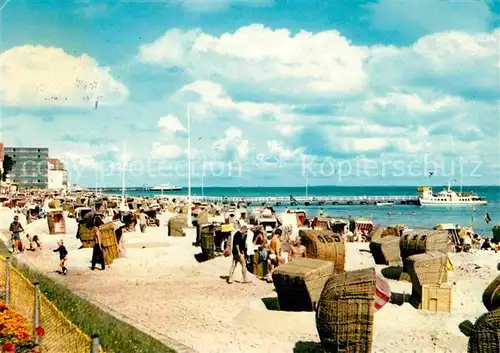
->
{"left": 273, "top": 258, "right": 333, "bottom": 311}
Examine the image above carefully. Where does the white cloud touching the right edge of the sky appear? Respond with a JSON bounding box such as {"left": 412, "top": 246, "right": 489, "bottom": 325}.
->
{"left": 366, "top": 29, "right": 500, "bottom": 98}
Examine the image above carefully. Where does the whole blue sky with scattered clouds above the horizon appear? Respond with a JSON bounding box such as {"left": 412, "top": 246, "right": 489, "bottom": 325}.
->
{"left": 0, "top": 0, "right": 500, "bottom": 187}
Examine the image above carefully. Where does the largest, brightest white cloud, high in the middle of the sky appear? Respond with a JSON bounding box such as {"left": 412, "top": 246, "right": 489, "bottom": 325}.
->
{"left": 138, "top": 24, "right": 367, "bottom": 96}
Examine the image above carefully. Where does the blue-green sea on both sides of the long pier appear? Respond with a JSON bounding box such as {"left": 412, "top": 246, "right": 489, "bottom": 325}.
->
{"left": 113, "top": 185, "right": 500, "bottom": 237}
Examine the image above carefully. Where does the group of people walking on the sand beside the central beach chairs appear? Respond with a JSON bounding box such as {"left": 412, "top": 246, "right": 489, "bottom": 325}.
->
{"left": 226, "top": 225, "right": 306, "bottom": 283}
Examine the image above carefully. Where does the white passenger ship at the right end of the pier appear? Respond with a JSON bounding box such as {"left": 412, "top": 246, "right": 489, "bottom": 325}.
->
{"left": 418, "top": 183, "right": 488, "bottom": 206}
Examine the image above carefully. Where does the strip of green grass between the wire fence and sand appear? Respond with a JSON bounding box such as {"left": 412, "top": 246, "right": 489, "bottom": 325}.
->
{"left": 0, "top": 241, "right": 175, "bottom": 353}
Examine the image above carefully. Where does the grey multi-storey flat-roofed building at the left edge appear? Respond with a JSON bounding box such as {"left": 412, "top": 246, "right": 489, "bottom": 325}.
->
{"left": 5, "top": 147, "right": 49, "bottom": 189}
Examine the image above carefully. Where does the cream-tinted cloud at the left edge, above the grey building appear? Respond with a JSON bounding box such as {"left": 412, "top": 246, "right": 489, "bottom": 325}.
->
{"left": 0, "top": 45, "right": 128, "bottom": 107}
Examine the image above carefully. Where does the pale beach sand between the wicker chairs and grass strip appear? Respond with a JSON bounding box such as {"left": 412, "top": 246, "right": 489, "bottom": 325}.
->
{"left": 0, "top": 209, "right": 500, "bottom": 353}
